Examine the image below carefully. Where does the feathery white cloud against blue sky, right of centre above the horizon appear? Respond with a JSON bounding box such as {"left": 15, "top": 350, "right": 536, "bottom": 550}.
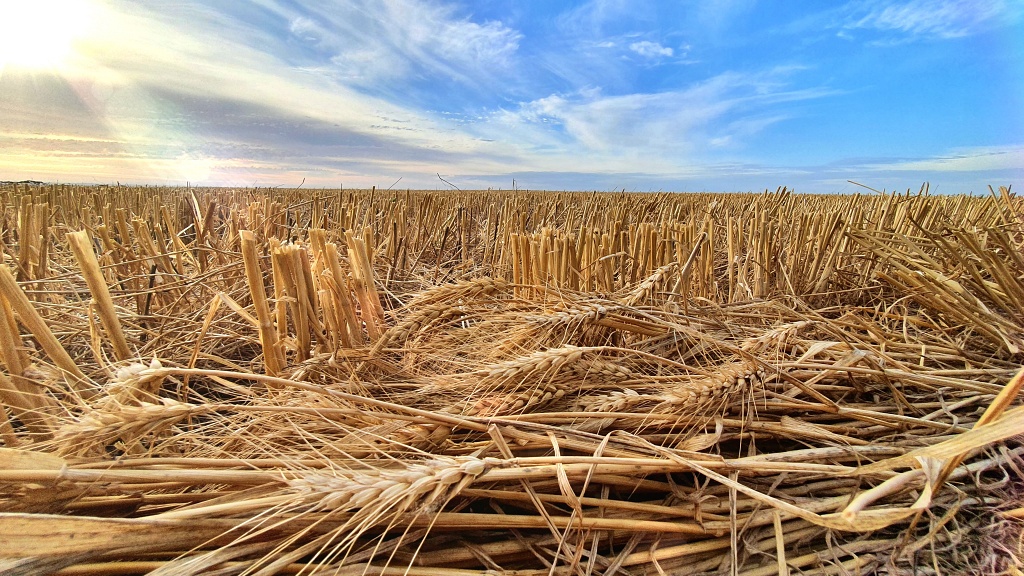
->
{"left": 490, "top": 69, "right": 833, "bottom": 169}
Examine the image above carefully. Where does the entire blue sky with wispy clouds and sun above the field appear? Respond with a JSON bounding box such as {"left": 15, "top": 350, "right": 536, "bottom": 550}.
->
{"left": 0, "top": 0, "right": 1024, "bottom": 194}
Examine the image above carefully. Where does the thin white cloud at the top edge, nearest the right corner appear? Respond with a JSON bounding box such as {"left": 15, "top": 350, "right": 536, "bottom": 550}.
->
{"left": 846, "top": 0, "right": 1014, "bottom": 39}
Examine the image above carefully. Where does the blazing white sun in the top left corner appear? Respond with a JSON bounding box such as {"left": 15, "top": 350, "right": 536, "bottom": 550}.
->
{"left": 0, "top": 0, "right": 91, "bottom": 71}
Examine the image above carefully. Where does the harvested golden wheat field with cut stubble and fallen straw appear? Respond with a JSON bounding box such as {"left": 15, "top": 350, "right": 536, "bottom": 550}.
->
{"left": 0, "top": 182, "right": 1024, "bottom": 576}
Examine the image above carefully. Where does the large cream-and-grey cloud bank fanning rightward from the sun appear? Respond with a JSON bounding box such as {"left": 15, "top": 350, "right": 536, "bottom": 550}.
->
{"left": 0, "top": 0, "right": 519, "bottom": 184}
